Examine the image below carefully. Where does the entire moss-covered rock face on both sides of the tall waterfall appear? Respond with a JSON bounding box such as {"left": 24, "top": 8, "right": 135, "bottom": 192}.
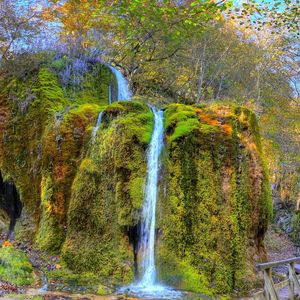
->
{"left": 0, "top": 61, "right": 272, "bottom": 294}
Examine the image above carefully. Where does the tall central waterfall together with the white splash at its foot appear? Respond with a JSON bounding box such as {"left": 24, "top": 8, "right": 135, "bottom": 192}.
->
{"left": 120, "top": 108, "right": 181, "bottom": 299}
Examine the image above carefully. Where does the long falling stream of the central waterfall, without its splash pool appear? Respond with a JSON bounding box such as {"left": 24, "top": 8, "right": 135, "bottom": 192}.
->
{"left": 140, "top": 109, "right": 164, "bottom": 287}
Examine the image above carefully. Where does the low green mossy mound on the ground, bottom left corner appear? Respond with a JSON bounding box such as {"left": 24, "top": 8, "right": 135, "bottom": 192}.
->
{"left": 0, "top": 246, "right": 34, "bottom": 286}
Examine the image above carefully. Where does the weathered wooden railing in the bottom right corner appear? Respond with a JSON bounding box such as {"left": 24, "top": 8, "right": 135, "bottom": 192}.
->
{"left": 254, "top": 257, "right": 300, "bottom": 300}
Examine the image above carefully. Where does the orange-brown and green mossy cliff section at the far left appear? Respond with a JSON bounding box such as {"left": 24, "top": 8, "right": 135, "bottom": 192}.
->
{"left": 0, "top": 63, "right": 110, "bottom": 251}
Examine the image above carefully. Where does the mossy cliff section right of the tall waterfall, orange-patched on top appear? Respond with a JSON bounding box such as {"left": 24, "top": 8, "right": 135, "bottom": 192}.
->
{"left": 157, "top": 104, "right": 272, "bottom": 293}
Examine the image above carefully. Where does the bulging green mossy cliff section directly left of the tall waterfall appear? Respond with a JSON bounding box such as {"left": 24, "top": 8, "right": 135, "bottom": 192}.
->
{"left": 62, "top": 102, "right": 153, "bottom": 284}
